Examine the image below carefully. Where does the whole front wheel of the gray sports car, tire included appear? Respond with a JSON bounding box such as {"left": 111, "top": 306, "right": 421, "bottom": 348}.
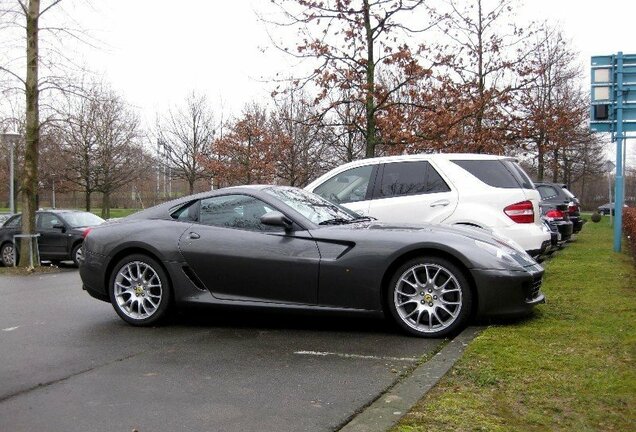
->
{"left": 386, "top": 256, "right": 472, "bottom": 338}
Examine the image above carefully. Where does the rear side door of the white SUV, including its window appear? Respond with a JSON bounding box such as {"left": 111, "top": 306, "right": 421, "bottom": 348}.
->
{"left": 369, "top": 161, "right": 457, "bottom": 223}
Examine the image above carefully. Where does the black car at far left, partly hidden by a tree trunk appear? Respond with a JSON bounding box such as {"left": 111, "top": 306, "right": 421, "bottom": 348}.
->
{"left": 0, "top": 210, "right": 104, "bottom": 266}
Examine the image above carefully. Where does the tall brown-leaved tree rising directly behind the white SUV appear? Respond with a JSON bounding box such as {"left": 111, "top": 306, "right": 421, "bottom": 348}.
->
{"left": 269, "top": 0, "right": 430, "bottom": 157}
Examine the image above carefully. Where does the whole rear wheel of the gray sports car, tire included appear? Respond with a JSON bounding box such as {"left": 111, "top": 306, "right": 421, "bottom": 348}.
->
{"left": 108, "top": 254, "right": 172, "bottom": 326}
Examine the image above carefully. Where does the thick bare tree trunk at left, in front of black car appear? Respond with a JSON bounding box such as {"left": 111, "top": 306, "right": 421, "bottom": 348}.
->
{"left": 18, "top": 0, "right": 40, "bottom": 267}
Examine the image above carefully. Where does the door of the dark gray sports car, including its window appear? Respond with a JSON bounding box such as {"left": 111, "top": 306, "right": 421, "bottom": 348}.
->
{"left": 179, "top": 194, "right": 320, "bottom": 304}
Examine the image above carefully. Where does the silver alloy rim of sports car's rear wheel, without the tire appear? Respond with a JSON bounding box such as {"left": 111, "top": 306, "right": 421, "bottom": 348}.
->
{"left": 113, "top": 261, "right": 163, "bottom": 320}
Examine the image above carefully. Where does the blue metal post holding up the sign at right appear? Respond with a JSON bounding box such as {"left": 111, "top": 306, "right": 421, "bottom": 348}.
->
{"left": 614, "top": 51, "right": 623, "bottom": 252}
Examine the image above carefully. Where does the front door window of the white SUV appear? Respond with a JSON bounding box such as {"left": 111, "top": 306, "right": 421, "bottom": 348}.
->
{"left": 314, "top": 165, "right": 374, "bottom": 204}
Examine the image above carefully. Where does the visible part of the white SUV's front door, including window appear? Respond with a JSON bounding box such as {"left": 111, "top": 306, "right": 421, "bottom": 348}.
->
{"left": 311, "top": 165, "right": 378, "bottom": 216}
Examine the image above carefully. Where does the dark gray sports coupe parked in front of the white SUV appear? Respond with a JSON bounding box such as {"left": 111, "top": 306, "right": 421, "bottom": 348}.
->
{"left": 80, "top": 186, "right": 544, "bottom": 337}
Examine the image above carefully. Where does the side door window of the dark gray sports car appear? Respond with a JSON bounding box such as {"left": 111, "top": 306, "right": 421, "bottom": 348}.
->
{"left": 199, "top": 195, "right": 283, "bottom": 231}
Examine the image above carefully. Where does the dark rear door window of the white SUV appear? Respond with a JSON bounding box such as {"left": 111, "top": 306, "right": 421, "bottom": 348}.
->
{"left": 378, "top": 161, "right": 429, "bottom": 198}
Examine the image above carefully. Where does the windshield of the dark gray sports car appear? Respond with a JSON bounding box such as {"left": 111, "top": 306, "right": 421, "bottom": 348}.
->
{"left": 265, "top": 187, "right": 361, "bottom": 224}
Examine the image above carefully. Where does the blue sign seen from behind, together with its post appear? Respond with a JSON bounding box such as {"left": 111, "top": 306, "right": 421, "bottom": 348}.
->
{"left": 590, "top": 52, "right": 636, "bottom": 252}
